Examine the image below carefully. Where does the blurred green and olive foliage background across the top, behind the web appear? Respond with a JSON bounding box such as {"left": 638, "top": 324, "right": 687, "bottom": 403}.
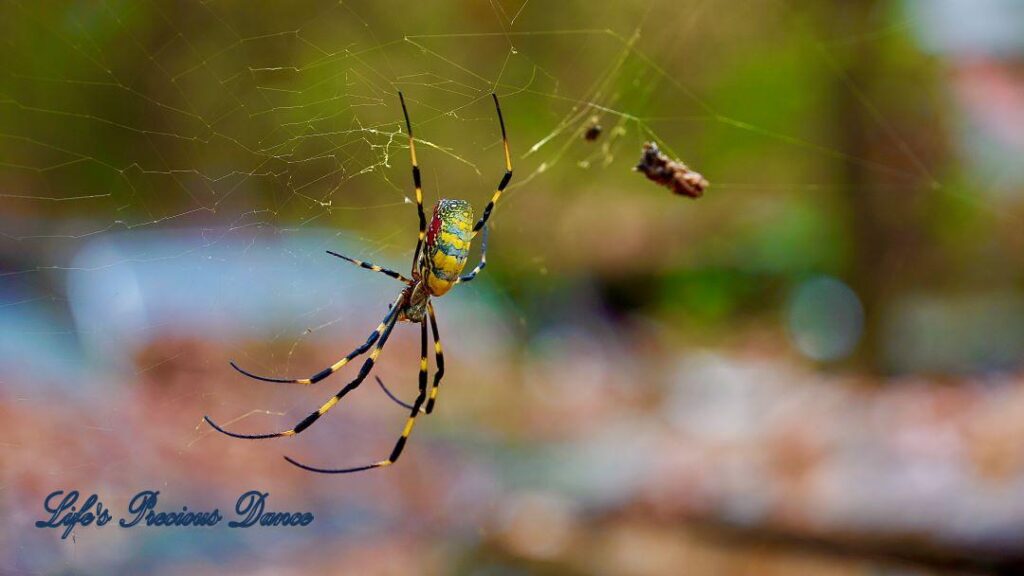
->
{"left": 6, "top": 1, "right": 1020, "bottom": 365}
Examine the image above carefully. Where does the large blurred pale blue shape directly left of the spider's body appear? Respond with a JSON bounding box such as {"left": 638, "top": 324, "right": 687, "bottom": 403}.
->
{"left": 68, "top": 230, "right": 396, "bottom": 362}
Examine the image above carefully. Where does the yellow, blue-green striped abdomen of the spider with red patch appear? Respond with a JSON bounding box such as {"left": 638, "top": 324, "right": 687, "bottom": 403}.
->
{"left": 424, "top": 200, "right": 473, "bottom": 296}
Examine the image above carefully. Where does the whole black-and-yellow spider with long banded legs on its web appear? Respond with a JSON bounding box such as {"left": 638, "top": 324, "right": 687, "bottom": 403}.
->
{"left": 203, "top": 92, "right": 512, "bottom": 474}
